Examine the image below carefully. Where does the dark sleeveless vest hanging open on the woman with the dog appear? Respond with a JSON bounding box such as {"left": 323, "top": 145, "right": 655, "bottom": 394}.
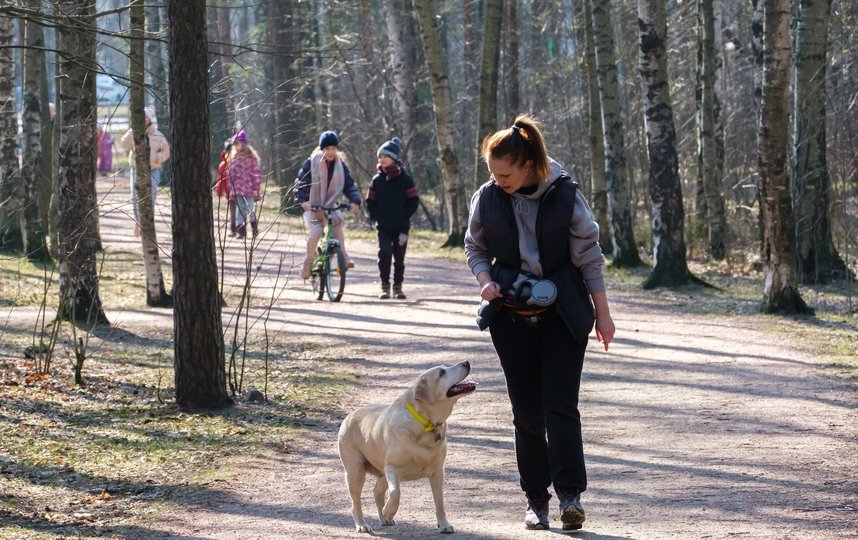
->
{"left": 479, "top": 174, "right": 594, "bottom": 341}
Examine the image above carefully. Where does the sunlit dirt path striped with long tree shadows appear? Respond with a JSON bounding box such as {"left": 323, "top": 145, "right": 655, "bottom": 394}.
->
{"left": 0, "top": 175, "right": 858, "bottom": 540}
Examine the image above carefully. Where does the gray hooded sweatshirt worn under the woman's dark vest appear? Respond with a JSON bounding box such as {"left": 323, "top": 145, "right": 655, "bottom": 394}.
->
{"left": 465, "top": 159, "right": 605, "bottom": 293}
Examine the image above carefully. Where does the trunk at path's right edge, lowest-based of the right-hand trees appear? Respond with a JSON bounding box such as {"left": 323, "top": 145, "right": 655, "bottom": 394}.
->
{"left": 759, "top": 0, "right": 813, "bottom": 313}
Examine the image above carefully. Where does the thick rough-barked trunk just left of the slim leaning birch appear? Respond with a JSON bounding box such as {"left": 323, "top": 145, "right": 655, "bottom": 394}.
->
{"left": 57, "top": 0, "right": 109, "bottom": 326}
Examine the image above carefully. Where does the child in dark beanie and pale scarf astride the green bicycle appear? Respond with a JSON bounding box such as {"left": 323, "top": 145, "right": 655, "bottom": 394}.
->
{"left": 294, "top": 131, "right": 361, "bottom": 279}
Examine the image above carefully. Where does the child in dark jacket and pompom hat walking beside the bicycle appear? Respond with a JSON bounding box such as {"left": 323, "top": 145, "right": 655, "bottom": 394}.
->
{"left": 366, "top": 137, "right": 420, "bottom": 300}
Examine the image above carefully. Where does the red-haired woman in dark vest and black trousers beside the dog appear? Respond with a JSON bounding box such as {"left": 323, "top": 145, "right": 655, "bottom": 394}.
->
{"left": 465, "top": 115, "right": 615, "bottom": 530}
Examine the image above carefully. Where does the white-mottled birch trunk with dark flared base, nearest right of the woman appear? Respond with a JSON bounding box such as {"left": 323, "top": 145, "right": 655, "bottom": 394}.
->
{"left": 638, "top": 0, "right": 691, "bottom": 289}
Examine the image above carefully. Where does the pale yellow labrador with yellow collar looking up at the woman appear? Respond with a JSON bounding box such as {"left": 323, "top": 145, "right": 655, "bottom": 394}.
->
{"left": 337, "top": 362, "right": 477, "bottom": 533}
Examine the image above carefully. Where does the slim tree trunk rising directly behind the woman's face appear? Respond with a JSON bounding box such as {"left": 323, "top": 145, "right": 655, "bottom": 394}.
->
{"left": 474, "top": 0, "right": 503, "bottom": 187}
